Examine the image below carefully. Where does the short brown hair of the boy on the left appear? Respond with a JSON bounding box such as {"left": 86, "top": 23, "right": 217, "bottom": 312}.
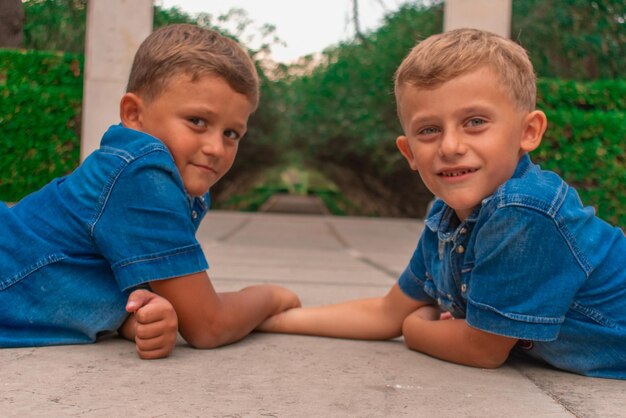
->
{"left": 126, "top": 24, "right": 259, "bottom": 109}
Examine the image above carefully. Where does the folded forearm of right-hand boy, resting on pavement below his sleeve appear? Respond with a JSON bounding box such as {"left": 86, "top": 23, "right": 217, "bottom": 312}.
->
{"left": 402, "top": 315, "right": 517, "bottom": 368}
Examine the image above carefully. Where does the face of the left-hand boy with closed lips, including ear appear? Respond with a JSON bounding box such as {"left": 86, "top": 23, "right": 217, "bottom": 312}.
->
{"left": 122, "top": 74, "right": 252, "bottom": 196}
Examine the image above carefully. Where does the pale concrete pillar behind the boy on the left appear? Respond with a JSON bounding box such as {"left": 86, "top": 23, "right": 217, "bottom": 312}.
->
{"left": 80, "top": 0, "right": 153, "bottom": 161}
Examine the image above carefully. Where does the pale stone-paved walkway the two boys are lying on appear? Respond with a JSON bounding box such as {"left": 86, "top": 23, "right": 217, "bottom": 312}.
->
{"left": 0, "top": 212, "right": 626, "bottom": 418}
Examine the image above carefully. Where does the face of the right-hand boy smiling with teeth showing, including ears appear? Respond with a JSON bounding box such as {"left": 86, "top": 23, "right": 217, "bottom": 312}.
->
{"left": 396, "top": 67, "right": 546, "bottom": 220}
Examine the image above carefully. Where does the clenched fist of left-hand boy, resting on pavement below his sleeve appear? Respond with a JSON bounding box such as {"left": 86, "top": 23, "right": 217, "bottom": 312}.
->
{"left": 120, "top": 289, "right": 178, "bottom": 359}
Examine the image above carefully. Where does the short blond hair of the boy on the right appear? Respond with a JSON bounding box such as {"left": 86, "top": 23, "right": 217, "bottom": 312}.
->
{"left": 395, "top": 29, "right": 537, "bottom": 111}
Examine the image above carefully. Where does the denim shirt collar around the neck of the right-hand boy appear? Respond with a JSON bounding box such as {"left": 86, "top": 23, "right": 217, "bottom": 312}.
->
{"left": 424, "top": 154, "right": 532, "bottom": 241}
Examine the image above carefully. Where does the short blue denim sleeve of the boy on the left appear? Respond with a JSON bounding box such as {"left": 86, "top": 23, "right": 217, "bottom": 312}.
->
{"left": 93, "top": 151, "right": 208, "bottom": 290}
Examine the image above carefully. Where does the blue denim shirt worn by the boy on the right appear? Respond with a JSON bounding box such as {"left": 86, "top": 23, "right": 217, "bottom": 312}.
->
{"left": 399, "top": 155, "right": 626, "bottom": 379}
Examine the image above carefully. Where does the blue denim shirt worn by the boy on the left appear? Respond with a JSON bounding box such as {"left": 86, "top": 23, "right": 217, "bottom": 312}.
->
{"left": 0, "top": 126, "right": 208, "bottom": 347}
